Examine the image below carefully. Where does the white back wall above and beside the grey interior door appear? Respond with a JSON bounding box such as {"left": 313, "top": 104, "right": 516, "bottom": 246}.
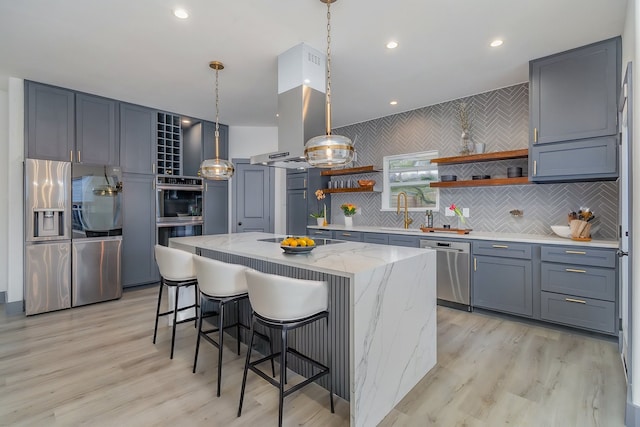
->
{"left": 229, "top": 126, "right": 287, "bottom": 234}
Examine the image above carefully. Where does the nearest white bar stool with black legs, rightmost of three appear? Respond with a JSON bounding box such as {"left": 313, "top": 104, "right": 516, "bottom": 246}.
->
{"left": 238, "top": 270, "right": 334, "bottom": 426}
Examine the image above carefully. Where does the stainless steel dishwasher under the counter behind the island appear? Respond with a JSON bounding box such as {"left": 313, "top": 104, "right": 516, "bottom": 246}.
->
{"left": 420, "top": 240, "right": 471, "bottom": 311}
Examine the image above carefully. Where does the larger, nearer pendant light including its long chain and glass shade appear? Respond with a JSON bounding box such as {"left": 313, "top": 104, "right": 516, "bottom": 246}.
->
{"left": 304, "top": 0, "right": 355, "bottom": 168}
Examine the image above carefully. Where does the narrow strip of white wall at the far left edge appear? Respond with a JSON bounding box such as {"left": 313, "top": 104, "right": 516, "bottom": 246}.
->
{"left": 0, "top": 90, "right": 9, "bottom": 298}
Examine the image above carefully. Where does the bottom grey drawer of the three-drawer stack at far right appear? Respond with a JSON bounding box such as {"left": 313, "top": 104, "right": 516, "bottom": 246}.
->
{"left": 540, "top": 292, "right": 615, "bottom": 334}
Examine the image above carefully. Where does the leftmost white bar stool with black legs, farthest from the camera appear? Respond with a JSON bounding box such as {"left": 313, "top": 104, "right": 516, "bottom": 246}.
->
{"left": 153, "top": 245, "right": 198, "bottom": 359}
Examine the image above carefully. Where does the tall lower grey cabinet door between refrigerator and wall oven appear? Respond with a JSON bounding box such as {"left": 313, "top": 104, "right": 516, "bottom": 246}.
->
{"left": 122, "top": 173, "right": 160, "bottom": 288}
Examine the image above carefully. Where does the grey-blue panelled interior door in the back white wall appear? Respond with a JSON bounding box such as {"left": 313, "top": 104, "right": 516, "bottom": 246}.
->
{"left": 232, "top": 159, "right": 275, "bottom": 233}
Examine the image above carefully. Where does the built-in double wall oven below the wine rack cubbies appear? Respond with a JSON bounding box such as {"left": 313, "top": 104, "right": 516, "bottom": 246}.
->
{"left": 156, "top": 175, "right": 204, "bottom": 246}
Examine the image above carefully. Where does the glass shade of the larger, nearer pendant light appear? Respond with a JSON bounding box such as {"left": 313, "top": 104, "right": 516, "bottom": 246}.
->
{"left": 304, "top": 135, "right": 355, "bottom": 168}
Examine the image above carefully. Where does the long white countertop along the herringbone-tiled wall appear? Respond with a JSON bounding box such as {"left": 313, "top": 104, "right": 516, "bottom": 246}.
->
{"left": 308, "top": 224, "right": 618, "bottom": 249}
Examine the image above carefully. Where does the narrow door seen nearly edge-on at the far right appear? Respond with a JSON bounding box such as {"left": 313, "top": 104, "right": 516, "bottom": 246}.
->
{"left": 618, "top": 62, "right": 633, "bottom": 382}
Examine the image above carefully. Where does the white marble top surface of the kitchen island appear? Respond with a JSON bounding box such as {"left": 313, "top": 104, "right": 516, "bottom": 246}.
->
{"left": 169, "top": 232, "right": 429, "bottom": 277}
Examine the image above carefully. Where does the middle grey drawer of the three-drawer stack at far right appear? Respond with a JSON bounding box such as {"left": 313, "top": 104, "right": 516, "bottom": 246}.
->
{"left": 540, "top": 262, "right": 616, "bottom": 301}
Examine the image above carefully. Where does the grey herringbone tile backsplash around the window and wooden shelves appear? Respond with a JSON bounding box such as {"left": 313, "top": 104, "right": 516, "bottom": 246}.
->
{"left": 331, "top": 83, "right": 618, "bottom": 239}
